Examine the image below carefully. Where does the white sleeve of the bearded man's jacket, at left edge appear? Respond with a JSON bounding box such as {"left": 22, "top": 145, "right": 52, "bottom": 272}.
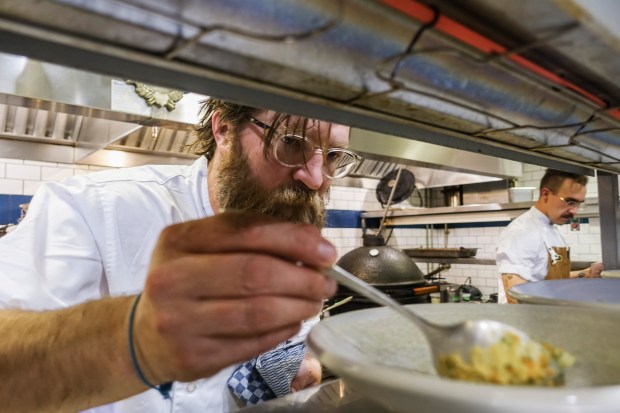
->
{"left": 0, "top": 183, "right": 106, "bottom": 310}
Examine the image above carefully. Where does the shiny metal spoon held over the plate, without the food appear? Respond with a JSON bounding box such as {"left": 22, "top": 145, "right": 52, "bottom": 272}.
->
{"left": 323, "top": 265, "right": 561, "bottom": 376}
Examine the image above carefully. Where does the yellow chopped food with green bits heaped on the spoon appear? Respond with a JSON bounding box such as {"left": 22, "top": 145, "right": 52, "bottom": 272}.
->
{"left": 438, "top": 333, "right": 575, "bottom": 386}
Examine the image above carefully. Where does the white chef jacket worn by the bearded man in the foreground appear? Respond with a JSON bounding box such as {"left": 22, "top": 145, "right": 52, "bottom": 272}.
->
{"left": 0, "top": 157, "right": 318, "bottom": 413}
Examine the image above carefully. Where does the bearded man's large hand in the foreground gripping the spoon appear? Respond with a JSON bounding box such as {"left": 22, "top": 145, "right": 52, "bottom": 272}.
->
{"left": 135, "top": 212, "right": 336, "bottom": 384}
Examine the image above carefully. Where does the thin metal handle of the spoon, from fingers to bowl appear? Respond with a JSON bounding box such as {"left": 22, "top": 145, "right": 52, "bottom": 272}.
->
{"left": 323, "top": 265, "right": 435, "bottom": 330}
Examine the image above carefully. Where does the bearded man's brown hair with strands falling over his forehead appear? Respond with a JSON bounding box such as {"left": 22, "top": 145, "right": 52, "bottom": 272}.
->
{"left": 190, "top": 98, "right": 329, "bottom": 160}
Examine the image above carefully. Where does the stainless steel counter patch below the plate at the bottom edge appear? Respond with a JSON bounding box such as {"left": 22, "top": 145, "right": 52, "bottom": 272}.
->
{"left": 236, "top": 379, "right": 389, "bottom": 413}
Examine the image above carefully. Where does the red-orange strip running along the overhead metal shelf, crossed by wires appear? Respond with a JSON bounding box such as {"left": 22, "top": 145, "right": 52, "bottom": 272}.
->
{"left": 380, "top": 0, "right": 620, "bottom": 119}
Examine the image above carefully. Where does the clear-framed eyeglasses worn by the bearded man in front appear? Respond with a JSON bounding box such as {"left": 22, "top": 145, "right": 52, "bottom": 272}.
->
{"left": 248, "top": 116, "right": 364, "bottom": 179}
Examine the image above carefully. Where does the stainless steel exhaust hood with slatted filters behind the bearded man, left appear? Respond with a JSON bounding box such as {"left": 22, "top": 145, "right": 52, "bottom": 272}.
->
{"left": 0, "top": 53, "right": 204, "bottom": 166}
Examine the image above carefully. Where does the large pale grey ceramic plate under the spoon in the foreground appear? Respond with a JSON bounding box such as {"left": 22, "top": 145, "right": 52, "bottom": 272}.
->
{"left": 308, "top": 304, "right": 620, "bottom": 413}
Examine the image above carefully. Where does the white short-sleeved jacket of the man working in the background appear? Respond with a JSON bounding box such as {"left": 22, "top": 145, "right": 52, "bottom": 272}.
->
{"left": 495, "top": 206, "right": 567, "bottom": 303}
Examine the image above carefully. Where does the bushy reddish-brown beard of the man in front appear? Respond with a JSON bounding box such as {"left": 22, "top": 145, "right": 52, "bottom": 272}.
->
{"left": 215, "top": 142, "right": 329, "bottom": 229}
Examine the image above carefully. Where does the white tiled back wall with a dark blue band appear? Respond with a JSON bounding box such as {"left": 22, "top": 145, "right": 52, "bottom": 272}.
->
{"left": 0, "top": 158, "right": 601, "bottom": 297}
